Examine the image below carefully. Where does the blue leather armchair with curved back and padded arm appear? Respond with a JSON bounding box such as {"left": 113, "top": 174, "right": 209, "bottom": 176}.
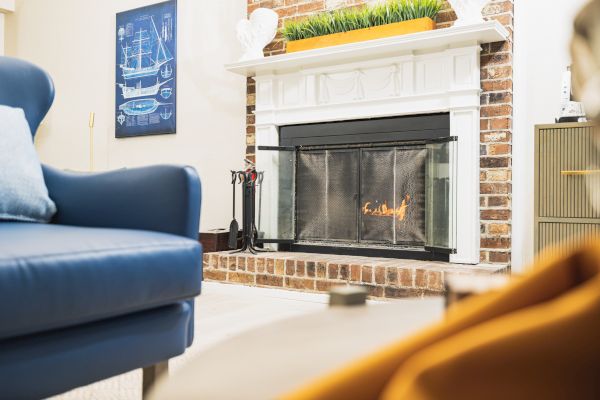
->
{"left": 0, "top": 57, "right": 202, "bottom": 399}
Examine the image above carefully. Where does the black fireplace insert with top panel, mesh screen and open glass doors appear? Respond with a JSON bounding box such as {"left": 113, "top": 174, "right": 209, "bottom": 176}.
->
{"left": 256, "top": 114, "right": 456, "bottom": 261}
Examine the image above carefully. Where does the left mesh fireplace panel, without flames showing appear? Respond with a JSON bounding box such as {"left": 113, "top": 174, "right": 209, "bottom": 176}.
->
{"left": 296, "top": 150, "right": 358, "bottom": 242}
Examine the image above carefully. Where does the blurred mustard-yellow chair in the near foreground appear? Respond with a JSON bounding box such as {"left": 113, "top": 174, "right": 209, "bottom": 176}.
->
{"left": 282, "top": 242, "right": 600, "bottom": 400}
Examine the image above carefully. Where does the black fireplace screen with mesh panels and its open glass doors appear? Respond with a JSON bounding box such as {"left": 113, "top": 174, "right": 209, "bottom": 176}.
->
{"left": 258, "top": 138, "right": 456, "bottom": 250}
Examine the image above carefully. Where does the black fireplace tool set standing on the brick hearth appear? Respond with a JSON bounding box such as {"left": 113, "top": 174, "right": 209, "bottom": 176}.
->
{"left": 228, "top": 159, "right": 266, "bottom": 254}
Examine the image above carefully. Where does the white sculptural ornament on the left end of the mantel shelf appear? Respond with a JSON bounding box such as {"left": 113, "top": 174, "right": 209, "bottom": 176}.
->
{"left": 237, "top": 8, "right": 279, "bottom": 61}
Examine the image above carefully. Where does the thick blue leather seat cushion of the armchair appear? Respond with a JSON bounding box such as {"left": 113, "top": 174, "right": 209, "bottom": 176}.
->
{"left": 0, "top": 222, "right": 202, "bottom": 339}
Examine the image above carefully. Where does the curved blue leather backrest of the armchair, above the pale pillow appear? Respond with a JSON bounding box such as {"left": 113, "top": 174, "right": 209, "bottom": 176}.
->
{"left": 0, "top": 56, "right": 54, "bottom": 136}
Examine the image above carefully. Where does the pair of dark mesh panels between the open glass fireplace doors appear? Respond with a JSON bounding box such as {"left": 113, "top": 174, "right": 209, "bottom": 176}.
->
{"left": 296, "top": 147, "right": 427, "bottom": 246}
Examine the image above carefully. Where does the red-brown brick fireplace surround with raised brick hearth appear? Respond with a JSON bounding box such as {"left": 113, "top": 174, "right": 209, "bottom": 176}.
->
{"left": 204, "top": 0, "right": 514, "bottom": 297}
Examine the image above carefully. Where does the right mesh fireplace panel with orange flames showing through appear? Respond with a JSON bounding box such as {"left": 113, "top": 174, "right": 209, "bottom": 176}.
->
{"left": 360, "top": 146, "right": 427, "bottom": 246}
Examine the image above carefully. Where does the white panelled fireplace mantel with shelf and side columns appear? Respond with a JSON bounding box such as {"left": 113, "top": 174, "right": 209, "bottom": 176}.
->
{"left": 227, "top": 21, "right": 509, "bottom": 264}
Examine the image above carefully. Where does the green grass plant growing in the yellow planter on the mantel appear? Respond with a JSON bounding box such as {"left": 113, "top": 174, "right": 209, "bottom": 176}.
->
{"left": 281, "top": 0, "right": 442, "bottom": 41}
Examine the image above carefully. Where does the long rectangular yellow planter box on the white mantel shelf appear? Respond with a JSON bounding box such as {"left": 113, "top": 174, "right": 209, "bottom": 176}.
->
{"left": 286, "top": 18, "right": 435, "bottom": 53}
